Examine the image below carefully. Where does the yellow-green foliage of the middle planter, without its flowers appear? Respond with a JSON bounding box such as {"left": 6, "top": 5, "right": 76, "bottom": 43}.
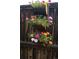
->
{"left": 28, "top": 17, "right": 49, "bottom": 29}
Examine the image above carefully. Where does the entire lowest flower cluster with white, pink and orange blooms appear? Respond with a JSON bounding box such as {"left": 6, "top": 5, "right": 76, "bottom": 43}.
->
{"left": 30, "top": 32, "right": 53, "bottom": 46}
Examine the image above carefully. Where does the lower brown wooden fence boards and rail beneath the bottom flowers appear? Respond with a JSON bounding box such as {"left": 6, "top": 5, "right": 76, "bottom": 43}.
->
{"left": 20, "top": 43, "right": 58, "bottom": 59}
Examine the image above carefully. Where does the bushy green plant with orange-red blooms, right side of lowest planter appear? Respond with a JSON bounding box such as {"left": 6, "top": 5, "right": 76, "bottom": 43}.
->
{"left": 39, "top": 32, "right": 53, "bottom": 46}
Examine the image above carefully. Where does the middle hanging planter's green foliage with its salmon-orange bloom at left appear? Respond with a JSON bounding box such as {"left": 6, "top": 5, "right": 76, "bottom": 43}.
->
{"left": 28, "top": 16, "right": 52, "bottom": 29}
